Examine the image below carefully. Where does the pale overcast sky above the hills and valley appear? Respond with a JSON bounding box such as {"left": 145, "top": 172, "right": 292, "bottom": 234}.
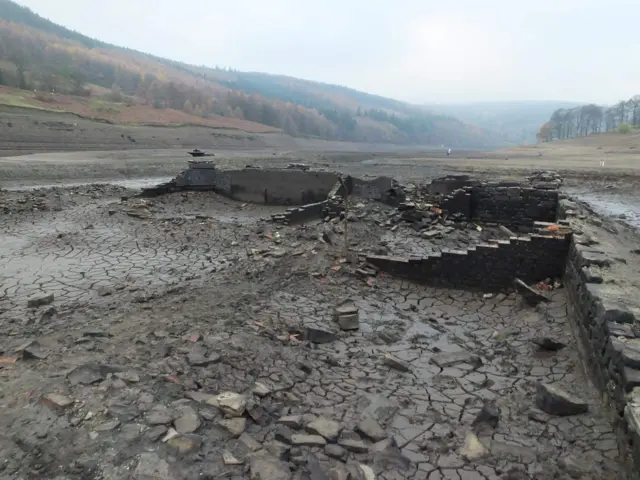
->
{"left": 13, "top": 0, "right": 640, "bottom": 103}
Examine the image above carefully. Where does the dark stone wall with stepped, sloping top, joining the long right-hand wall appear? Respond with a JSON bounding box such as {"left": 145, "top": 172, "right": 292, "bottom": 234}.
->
{"left": 367, "top": 235, "right": 569, "bottom": 291}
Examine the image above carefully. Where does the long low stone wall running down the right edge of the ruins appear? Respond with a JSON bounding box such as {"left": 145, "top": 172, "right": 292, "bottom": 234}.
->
{"left": 560, "top": 202, "right": 640, "bottom": 478}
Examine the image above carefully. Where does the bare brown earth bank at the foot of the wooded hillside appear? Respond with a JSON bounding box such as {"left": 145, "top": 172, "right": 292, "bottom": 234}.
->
{"left": 0, "top": 105, "right": 438, "bottom": 157}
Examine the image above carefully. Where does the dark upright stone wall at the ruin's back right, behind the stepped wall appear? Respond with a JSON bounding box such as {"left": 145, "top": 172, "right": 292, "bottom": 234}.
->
{"left": 440, "top": 183, "right": 558, "bottom": 226}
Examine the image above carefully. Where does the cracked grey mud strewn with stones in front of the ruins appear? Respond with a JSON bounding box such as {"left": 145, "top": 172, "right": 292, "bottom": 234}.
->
{"left": 0, "top": 167, "right": 631, "bottom": 480}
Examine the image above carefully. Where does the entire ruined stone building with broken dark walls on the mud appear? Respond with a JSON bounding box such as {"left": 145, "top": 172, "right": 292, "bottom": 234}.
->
{"left": 143, "top": 162, "right": 640, "bottom": 471}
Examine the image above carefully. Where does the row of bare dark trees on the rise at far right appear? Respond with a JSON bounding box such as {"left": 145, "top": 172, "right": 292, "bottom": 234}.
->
{"left": 538, "top": 95, "right": 640, "bottom": 142}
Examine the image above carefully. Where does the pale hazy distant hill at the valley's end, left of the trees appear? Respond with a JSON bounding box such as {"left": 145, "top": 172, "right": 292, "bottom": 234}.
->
{"left": 427, "top": 101, "right": 578, "bottom": 145}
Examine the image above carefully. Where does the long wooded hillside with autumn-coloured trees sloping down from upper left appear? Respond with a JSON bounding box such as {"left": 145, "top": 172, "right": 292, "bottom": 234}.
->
{"left": 0, "top": 0, "right": 503, "bottom": 148}
